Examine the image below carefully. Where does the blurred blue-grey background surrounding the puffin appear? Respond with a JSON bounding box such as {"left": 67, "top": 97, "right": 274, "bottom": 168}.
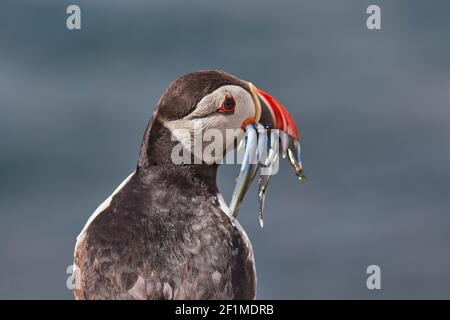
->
{"left": 0, "top": 0, "right": 450, "bottom": 299}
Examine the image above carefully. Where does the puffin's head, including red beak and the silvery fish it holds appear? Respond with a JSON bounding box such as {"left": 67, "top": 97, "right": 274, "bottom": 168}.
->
{"left": 138, "top": 70, "right": 305, "bottom": 226}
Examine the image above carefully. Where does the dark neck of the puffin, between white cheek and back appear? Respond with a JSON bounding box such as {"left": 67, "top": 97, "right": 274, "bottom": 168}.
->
{"left": 136, "top": 120, "right": 218, "bottom": 194}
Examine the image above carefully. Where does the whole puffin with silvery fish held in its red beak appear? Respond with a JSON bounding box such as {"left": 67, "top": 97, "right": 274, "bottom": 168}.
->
{"left": 73, "top": 70, "right": 305, "bottom": 300}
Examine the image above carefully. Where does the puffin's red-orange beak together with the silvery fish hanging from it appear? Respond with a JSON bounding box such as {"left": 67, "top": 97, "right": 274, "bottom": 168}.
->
{"left": 230, "top": 83, "right": 306, "bottom": 227}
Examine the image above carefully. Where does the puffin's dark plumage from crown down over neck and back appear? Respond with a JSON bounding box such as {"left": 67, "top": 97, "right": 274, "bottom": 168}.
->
{"left": 75, "top": 71, "right": 256, "bottom": 299}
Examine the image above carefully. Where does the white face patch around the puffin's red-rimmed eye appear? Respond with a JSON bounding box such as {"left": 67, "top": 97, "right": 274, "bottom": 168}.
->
{"left": 164, "top": 85, "right": 256, "bottom": 163}
